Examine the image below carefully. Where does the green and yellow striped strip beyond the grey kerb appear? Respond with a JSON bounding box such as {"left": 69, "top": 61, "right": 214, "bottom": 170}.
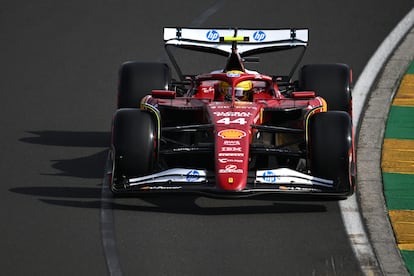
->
{"left": 381, "top": 62, "right": 414, "bottom": 272}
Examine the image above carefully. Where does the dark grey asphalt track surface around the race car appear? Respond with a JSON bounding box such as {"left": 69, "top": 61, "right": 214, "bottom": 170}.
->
{"left": 0, "top": 0, "right": 413, "bottom": 275}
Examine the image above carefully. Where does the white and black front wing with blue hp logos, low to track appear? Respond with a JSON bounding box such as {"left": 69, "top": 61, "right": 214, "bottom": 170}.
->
{"left": 108, "top": 163, "right": 346, "bottom": 197}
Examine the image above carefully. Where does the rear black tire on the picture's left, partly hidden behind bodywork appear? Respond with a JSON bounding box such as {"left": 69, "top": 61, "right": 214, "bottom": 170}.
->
{"left": 117, "top": 61, "right": 171, "bottom": 108}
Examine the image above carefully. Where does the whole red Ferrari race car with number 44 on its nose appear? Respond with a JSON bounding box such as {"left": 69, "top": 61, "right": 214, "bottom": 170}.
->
{"left": 108, "top": 28, "right": 356, "bottom": 198}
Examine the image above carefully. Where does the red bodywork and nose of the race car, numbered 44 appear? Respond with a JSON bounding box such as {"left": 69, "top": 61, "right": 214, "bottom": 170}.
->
{"left": 143, "top": 73, "right": 326, "bottom": 191}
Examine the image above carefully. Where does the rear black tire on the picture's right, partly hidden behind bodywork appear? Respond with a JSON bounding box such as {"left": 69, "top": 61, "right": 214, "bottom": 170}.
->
{"left": 299, "top": 63, "right": 352, "bottom": 113}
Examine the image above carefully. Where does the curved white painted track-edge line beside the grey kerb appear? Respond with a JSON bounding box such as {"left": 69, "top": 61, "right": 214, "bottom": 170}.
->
{"left": 339, "top": 9, "right": 414, "bottom": 275}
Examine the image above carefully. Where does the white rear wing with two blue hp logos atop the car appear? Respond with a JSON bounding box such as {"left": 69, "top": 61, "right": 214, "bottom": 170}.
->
{"left": 164, "top": 27, "right": 308, "bottom": 56}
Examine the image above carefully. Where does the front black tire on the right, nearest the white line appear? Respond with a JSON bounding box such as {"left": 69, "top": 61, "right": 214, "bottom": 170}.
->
{"left": 308, "top": 111, "right": 354, "bottom": 196}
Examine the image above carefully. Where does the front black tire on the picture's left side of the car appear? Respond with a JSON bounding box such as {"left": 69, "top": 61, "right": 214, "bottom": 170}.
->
{"left": 112, "top": 108, "right": 157, "bottom": 185}
